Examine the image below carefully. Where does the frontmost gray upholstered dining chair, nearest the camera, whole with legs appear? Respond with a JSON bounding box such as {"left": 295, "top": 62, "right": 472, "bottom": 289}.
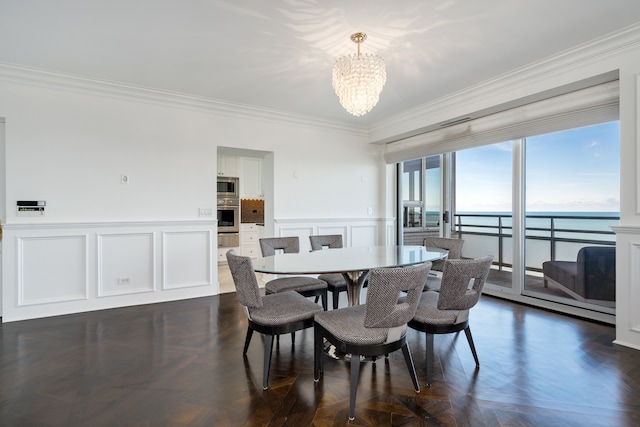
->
{"left": 313, "top": 262, "right": 431, "bottom": 420}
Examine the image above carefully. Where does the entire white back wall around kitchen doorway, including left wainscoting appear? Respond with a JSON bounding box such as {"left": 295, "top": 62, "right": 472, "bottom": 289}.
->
{"left": 0, "top": 71, "right": 387, "bottom": 322}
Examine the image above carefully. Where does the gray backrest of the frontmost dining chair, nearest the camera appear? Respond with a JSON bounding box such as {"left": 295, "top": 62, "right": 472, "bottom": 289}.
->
{"left": 364, "top": 262, "right": 431, "bottom": 332}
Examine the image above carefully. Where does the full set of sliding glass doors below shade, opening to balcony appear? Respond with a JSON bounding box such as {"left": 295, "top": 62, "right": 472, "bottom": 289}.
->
{"left": 401, "top": 121, "right": 620, "bottom": 313}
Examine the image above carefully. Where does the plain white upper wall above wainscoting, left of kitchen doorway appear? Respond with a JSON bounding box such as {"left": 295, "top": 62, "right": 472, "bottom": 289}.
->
{"left": 0, "top": 83, "right": 216, "bottom": 224}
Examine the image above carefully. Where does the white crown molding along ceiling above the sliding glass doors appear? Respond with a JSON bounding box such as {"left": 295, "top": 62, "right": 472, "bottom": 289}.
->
{"left": 369, "top": 23, "right": 640, "bottom": 143}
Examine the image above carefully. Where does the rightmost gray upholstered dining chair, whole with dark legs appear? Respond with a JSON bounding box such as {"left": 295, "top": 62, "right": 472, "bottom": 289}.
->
{"left": 409, "top": 255, "right": 493, "bottom": 386}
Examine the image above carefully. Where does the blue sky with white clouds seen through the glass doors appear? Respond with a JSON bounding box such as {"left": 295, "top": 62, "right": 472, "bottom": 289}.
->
{"left": 452, "top": 121, "right": 620, "bottom": 212}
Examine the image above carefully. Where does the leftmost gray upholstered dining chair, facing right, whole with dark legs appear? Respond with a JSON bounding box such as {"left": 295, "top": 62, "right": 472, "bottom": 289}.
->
{"left": 226, "top": 250, "right": 322, "bottom": 390}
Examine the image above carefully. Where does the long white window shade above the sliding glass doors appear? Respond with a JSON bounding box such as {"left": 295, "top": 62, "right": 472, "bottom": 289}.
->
{"left": 384, "top": 80, "right": 619, "bottom": 164}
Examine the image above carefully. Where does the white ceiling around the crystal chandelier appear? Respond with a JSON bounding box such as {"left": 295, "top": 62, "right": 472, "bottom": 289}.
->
{"left": 0, "top": 0, "right": 640, "bottom": 126}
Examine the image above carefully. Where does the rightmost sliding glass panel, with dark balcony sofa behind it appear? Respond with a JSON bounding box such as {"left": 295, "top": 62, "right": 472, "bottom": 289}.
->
{"left": 524, "top": 121, "right": 620, "bottom": 313}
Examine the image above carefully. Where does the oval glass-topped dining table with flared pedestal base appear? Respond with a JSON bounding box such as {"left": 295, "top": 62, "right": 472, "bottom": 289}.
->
{"left": 253, "top": 246, "right": 447, "bottom": 306}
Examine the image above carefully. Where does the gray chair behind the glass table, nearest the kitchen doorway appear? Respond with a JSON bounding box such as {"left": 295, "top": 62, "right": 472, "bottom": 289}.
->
{"left": 258, "top": 236, "right": 327, "bottom": 310}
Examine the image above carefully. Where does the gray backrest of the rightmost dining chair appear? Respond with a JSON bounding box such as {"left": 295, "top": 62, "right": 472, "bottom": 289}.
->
{"left": 438, "top": 255, "right": 493, "bottom": 310}
